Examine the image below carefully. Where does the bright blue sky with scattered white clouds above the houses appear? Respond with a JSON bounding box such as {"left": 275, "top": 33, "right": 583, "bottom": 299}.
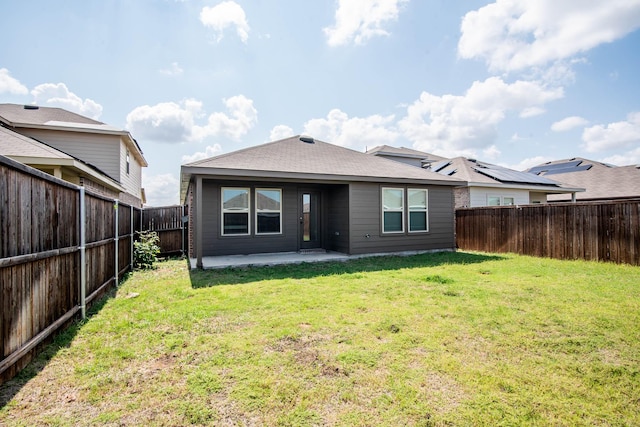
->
{"left": 0, "top": 0, "right": 640, "bottom": 205}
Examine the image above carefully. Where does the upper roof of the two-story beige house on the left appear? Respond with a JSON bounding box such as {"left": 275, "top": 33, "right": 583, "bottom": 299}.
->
{"left": 0, "top": 104, "right": 148, "bottom": 166}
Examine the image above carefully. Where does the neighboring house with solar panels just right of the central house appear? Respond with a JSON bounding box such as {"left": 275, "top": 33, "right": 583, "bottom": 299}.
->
{"left": 367, "top": 146, "right": 584, "bottom": 209}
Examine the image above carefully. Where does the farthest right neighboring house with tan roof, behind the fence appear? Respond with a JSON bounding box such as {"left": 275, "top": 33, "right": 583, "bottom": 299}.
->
{"left": 527, "top": 157, "right": 640, "bottom": 202}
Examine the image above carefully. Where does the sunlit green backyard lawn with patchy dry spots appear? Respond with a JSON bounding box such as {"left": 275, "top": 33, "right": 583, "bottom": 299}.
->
{"left": 0, "top": 252, "right": 640, "bottom": 426}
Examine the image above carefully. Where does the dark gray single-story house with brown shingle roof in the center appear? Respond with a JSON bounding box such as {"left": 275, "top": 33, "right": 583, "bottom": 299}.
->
{"left": 181, "top": 136, "right": 461, "bottom": 267}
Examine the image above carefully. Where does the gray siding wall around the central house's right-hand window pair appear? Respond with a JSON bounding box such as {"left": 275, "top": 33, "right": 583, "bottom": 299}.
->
{"left": 349, "top": 183, "right": 455, "bottom": 254}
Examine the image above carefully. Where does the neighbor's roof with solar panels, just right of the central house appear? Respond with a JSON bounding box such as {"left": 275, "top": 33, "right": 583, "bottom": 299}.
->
{"left": 430, "top": 157, "right": 583, "bottom": 193}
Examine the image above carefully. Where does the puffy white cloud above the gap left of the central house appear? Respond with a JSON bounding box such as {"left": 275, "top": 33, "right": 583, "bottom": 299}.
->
{"left": 127, "top": 95, "right": 258, "bottom": 143}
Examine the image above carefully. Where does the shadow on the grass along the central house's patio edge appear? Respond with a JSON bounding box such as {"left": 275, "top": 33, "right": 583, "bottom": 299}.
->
{"left": 189, "top": 252, "right": 505, "bottom": 289}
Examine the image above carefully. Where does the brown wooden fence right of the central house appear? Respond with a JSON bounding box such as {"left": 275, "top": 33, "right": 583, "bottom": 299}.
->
{"left": 456, "top": 201, "right": 640, "bottom": 265}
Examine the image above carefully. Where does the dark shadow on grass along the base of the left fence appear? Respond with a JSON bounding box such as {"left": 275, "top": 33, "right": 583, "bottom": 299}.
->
{"left": 0, "top": 274, "right": 130, "bottom": 409}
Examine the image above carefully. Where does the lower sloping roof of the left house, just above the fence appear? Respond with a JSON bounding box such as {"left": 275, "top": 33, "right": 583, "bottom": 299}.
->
{"left": 0, "top": 126, "right": 124, "bottom": 191}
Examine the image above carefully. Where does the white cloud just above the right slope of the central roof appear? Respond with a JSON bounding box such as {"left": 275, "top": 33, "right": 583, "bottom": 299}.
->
{"left": 304, "top": 109, "right": 399, "bottom": 149}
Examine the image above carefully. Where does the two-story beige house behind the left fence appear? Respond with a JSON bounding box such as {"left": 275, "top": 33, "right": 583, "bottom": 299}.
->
{"left": 0, "top": 104, "right": 148, "bottom": 207}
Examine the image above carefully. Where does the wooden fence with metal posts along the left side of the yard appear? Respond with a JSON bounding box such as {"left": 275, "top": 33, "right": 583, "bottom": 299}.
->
{"left": 0, "top": 156, "right": 188, "bottom": 383}
